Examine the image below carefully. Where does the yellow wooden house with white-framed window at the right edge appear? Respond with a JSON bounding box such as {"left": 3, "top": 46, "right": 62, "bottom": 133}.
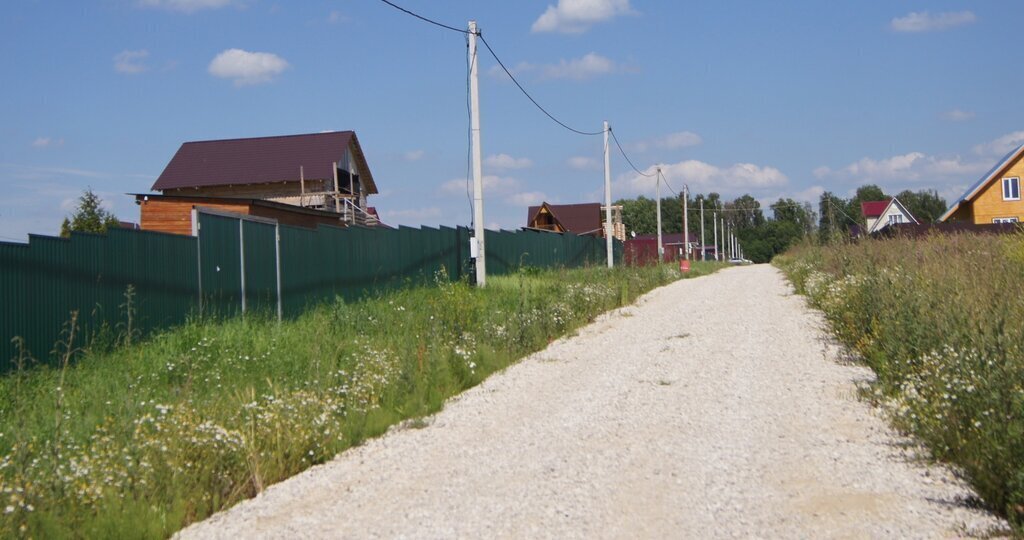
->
{"left": 939, "top": 144, "right": 1024, "bottom": 224}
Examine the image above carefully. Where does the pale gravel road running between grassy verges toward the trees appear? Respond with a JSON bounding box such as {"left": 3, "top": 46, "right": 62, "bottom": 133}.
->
{"left": 180, "top": 265, "right": 1005, "bottom": 539}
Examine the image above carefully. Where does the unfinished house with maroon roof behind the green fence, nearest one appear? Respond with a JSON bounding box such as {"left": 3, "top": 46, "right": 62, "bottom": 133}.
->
{"left": 142, "top": 131, "right": 379, "bottom": 234}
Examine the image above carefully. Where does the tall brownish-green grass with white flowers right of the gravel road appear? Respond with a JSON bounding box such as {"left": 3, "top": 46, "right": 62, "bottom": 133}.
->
{"left": 776, "top": 234, "right": 1024, "bottom": 534}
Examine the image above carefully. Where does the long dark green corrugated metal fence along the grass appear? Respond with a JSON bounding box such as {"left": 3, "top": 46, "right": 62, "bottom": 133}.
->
{"left": 0, "top": 210, "right": 622, "bottom": 373}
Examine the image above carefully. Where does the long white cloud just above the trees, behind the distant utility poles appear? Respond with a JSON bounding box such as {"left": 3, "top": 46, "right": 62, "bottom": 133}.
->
{"left": 613, "top": 160, "right": 790, "bottom": 198}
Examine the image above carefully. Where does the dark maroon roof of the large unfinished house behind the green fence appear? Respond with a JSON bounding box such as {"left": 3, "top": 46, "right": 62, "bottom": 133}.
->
{"left": 153, "top": 131, "right": 377, "bottom": 194}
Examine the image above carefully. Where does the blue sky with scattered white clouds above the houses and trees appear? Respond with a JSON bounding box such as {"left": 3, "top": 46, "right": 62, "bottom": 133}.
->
{"left": 0, "top": 0, "right": 1024, "bottom": 241}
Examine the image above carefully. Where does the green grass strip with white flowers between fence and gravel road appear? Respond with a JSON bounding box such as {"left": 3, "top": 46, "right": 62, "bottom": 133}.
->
{"left": 0, "top": 264, "right": 718, "bottom": 538}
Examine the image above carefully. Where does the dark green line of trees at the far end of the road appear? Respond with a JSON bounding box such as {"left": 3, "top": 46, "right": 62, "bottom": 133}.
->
{"left": 615, "top": 184, "right": 946, "bottom": 262}
